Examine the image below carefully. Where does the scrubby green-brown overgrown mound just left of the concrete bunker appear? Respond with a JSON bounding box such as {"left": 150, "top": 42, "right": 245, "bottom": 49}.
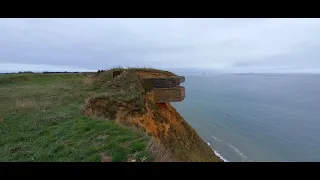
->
{"left": 84, "top": 68, "right": 146, "bottom": 119}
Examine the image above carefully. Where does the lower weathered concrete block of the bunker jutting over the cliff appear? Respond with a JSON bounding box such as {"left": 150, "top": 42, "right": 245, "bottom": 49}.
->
{"left": 152, "top": 86, "right": 185, "bottom": 103}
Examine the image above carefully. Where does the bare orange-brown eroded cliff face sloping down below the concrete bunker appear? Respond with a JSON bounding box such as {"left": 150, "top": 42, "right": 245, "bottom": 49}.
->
{"left": 117, "top": 96, "right": 220, "bottom": 162}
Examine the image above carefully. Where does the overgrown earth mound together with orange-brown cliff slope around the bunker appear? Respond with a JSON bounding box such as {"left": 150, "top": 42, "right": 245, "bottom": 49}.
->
{"left": 83, "top": 69, "right": 221, "bottom": 162}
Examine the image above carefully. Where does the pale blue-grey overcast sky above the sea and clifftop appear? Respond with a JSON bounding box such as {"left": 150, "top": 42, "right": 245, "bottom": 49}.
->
{"left": 0, "top": 18, "right": 320, "bottom": 72}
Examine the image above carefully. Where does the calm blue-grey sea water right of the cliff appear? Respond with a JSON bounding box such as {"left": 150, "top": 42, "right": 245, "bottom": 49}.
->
{"left": 172, "top": 74, "right": 320, "bottom": 162}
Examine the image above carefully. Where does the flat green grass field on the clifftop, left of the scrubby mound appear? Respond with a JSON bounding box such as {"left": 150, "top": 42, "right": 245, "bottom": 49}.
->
{"left": 0, "top": 74, "right": 152, "bottom": 162}
